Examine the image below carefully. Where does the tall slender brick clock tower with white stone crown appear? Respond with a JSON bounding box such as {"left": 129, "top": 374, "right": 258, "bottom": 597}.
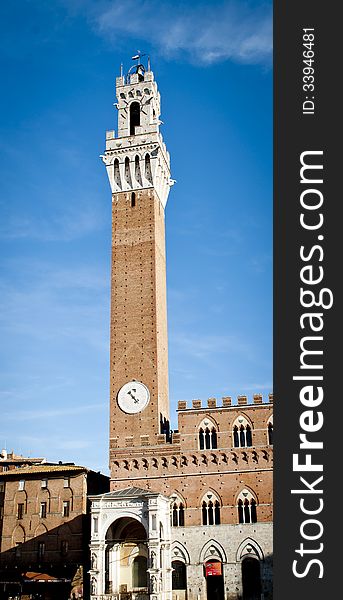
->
{"left": 102, "top": 58, "right": 173, "bottom": 486}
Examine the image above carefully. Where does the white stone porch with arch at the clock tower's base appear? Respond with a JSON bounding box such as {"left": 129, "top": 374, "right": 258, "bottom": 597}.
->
{"left": 89, "top": 487, "right": 172, "bottom": 600}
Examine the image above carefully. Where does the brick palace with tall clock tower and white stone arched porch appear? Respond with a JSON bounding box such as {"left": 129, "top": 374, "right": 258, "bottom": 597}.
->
{"left": 89, "top": 57, "right": 273, "bottom": 600}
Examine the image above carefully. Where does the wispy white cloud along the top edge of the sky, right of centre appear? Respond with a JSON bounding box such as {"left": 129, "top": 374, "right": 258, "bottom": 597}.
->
{"left": 92, "top": 0, "right": 272, "bottom": 65}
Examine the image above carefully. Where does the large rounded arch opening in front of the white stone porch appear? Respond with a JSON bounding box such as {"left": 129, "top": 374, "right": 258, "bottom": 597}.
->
{"left": 105, "top": 517, "right": 148, "bottom": 594}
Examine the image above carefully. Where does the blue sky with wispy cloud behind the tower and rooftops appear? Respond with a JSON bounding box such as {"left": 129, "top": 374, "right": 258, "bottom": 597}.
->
{"left": 0, "top": 0, "right": 272, "bottom": 472}
